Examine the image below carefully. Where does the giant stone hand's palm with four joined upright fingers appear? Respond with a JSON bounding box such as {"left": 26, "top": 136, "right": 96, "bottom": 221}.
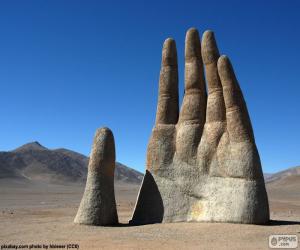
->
{"left": 131, "top": 28, "right": 269, "bottom": 224}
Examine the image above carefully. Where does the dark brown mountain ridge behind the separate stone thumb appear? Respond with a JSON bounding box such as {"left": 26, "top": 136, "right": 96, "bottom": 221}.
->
{"left": 0, "top": 142, "right": 143, "bottom": 184}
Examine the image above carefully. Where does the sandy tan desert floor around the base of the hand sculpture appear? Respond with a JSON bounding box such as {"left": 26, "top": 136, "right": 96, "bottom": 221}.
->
{"left": 0, "top": 180, "right": 300, "bottom": 249}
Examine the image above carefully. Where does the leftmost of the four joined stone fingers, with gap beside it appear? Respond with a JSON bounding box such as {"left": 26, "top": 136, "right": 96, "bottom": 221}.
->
{"left": 156, "top": 38, "right": 179, "bottom": 124}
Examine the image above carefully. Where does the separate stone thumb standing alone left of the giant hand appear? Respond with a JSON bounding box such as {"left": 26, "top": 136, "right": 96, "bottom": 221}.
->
{"left": 74, "top": 128, "right": 118, "bottom": 226}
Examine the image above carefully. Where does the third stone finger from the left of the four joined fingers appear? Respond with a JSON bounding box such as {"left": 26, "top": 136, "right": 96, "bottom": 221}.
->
{"left": 201, "top": 30, "right": 225, "bottom": 123}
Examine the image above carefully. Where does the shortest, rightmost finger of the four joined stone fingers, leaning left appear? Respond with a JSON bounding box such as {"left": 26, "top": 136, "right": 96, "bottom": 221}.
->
{"left": 218, "top": 56, "right": 254, "bottom": 142}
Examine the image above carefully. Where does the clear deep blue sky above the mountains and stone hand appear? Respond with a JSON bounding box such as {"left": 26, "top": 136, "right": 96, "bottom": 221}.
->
{"left": 0, "top": 0, "right": 300, "bottom": 172}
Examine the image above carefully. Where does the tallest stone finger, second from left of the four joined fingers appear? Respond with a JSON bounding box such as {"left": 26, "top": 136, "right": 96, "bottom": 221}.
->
{"left": 176, "top": 28, "right": 206, "bottom": 164}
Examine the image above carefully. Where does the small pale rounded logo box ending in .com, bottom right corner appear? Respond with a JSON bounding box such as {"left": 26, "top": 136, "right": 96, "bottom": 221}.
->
{"left": 269, "top": 234, "right": 298, "bottom": 248}
